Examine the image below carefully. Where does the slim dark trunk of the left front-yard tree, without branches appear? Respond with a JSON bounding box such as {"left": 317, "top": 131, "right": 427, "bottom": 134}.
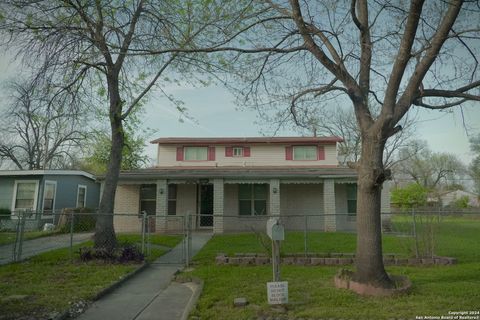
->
{"left": 95, "top": 76, "right": 124, "bottom": 250}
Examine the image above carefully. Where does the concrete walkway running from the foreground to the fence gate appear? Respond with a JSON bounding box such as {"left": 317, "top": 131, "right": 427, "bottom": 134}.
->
{"left": 77, "top": 233, "right": 211, "bottom": 320}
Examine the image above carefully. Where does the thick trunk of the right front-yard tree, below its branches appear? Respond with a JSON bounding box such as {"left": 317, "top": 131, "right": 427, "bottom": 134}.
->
{"left": 354, "top": 132, "right": 393, "bottom": 288}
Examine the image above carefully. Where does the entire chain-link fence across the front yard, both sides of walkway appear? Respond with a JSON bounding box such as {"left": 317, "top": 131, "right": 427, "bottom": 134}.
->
{"left": 0, "top": 209, "right": 480, "bottom": 265}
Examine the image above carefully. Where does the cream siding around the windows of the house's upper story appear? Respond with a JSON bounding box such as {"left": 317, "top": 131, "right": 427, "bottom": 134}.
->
{"left": 157, "top": 145, "right": 338, "bottom": 167}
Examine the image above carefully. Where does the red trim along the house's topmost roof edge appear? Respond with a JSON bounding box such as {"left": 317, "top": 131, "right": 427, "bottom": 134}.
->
{"left": 150, "top": 137, "right": 343, "bottom": 145}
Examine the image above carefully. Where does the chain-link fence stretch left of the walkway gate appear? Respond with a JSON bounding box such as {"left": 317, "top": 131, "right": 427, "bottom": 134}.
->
{"left": 0, "top": 209, "right": 189, "bottom": 265}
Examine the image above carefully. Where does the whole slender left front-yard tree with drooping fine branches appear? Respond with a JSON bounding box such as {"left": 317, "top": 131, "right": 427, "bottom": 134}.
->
{"left": 0, "top": 0, "right": 255, "bottom": 248}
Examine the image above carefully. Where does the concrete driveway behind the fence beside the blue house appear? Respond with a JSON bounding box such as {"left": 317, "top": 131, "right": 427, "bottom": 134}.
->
{"left": 0, "top": 233, "right": 93, "bottom": 265}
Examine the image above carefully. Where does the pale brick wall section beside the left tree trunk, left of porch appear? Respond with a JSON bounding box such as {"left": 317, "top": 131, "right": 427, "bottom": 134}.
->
{"left": 113, "top": 185, "right": 142, "bottom": 232}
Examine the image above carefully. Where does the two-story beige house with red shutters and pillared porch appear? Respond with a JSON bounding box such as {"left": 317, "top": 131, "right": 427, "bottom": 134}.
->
{"left": 110, "top": 137, "right": 390, "bottom": 233}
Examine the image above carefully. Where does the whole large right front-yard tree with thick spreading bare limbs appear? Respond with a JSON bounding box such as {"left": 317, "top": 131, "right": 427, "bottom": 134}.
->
{"left": 189, "top": 0, "right": 480, "bottom": 287}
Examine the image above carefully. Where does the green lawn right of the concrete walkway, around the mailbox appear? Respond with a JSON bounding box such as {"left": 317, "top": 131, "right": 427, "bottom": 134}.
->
{"left": 184, "top": 218, "right": 480, "bottom": 319}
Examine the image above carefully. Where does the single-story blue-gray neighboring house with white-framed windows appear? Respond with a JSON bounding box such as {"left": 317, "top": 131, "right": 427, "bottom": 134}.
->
{"left": 0, "top": 170, "right": 100, "bottom": 216}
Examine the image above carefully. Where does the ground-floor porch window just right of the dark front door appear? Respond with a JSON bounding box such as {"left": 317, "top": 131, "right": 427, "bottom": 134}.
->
{"left": 238, "top": 184, "right": 268, "bottom": 216}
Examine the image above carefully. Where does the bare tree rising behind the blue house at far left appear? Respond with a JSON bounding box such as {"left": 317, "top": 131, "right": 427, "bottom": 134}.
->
{"left": 0, "top": 80, "right": 86, "bottom": 170}
